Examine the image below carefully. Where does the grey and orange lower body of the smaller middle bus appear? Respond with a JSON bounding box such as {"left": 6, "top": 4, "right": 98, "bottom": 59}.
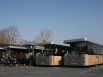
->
{"left": 36, "top": 55, "right": 62, "bottom": 66}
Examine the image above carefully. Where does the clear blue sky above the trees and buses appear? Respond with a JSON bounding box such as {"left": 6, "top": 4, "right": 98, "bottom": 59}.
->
{"left": 0, "top": 0, "right": 103, "bottom": 43}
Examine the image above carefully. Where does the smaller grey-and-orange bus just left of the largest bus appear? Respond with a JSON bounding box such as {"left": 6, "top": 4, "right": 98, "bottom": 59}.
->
{"left": 36, "top": 43, "right": 69, "bottom": 66}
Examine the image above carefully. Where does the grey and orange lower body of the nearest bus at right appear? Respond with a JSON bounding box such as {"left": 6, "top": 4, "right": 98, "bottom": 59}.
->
{"left": 64, "top": 54, "right": 103, "bottom": 66}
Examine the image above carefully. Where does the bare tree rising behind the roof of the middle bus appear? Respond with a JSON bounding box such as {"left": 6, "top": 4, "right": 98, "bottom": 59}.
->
{"left": 34, "top": 29, "right": 52, "bottom": 43}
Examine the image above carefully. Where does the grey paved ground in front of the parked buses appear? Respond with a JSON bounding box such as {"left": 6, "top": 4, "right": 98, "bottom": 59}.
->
{"left": 0, "top": 66, "right": 103, "bottom": 77}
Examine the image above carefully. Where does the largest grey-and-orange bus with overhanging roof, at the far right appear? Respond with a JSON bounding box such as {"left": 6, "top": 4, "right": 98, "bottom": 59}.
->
{"left": 64, "top": 38, "right": 103, "bottom": 66}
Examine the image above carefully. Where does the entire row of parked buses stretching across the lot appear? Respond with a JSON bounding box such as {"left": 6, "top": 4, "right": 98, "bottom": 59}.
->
{"left": 0, "top": 38, "right": 103, "bottom": 66}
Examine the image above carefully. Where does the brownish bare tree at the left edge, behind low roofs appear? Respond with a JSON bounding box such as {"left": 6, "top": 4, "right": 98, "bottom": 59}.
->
{"left": 0, "top": 26, "right": 20, "bottom": 44}
